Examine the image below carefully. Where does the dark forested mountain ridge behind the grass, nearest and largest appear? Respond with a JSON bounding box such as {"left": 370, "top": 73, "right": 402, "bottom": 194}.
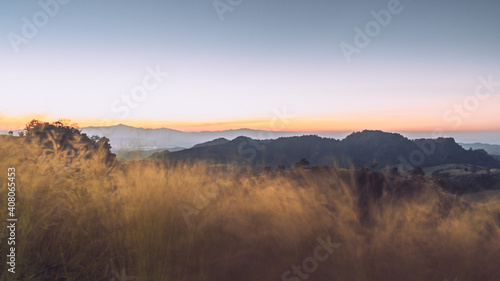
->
{"left": 150, "top": 130, "right": 500, "bottom": 170}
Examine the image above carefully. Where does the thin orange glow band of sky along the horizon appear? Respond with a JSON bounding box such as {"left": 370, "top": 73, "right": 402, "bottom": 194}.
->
{"left": 0, "top": 114, "right": 500, "bottom": 133}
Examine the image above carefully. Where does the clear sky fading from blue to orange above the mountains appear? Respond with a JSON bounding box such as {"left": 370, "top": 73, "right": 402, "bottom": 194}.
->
{"left": 0, "top": 0, "right": 500, "bottom": 135}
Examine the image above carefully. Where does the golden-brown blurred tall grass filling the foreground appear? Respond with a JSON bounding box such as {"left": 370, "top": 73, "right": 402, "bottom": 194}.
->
{"left": 0, "top": 135, "right": 500, "bottom": 281}
